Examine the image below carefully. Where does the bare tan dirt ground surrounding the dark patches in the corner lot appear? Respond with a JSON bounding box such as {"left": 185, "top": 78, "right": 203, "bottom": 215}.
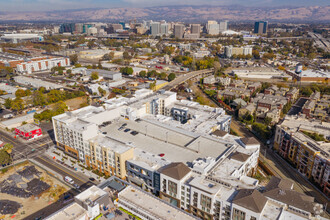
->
{"left": 0, "top": 162, "right": 69, "bottom": 219}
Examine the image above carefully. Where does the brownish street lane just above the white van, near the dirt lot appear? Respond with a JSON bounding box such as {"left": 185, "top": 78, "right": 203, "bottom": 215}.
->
{"left": 34, "top": 156, "right": 89, "bottom": 186}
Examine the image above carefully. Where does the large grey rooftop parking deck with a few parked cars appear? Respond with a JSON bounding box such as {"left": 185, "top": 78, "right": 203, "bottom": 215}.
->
{"left": 101, "top": 118, "right": 233, "bottom": 164}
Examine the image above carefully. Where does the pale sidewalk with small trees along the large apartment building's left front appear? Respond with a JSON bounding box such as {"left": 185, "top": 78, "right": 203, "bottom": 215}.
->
{"left": 45, "top": 147, "right": 105, "bottom": 182}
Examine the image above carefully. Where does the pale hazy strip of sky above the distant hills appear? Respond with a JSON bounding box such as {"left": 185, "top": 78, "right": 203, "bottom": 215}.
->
{"left": 0, "top": 0, "right": 330, "bottom": 12}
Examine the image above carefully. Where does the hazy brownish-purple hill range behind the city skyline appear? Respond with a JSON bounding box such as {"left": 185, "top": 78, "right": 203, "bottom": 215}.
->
{"left": 0, "top": 6, "right": 330, "bottom": 21}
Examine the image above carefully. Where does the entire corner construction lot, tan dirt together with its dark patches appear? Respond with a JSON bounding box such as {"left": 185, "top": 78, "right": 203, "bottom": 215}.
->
{"left": 0, "top": 161, "right": 69, "bottom": 219}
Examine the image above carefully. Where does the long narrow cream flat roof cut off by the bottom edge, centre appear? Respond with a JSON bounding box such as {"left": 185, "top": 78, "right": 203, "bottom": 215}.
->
{"left": 119, "top": 186, "right": 196, "bottom": 220}
